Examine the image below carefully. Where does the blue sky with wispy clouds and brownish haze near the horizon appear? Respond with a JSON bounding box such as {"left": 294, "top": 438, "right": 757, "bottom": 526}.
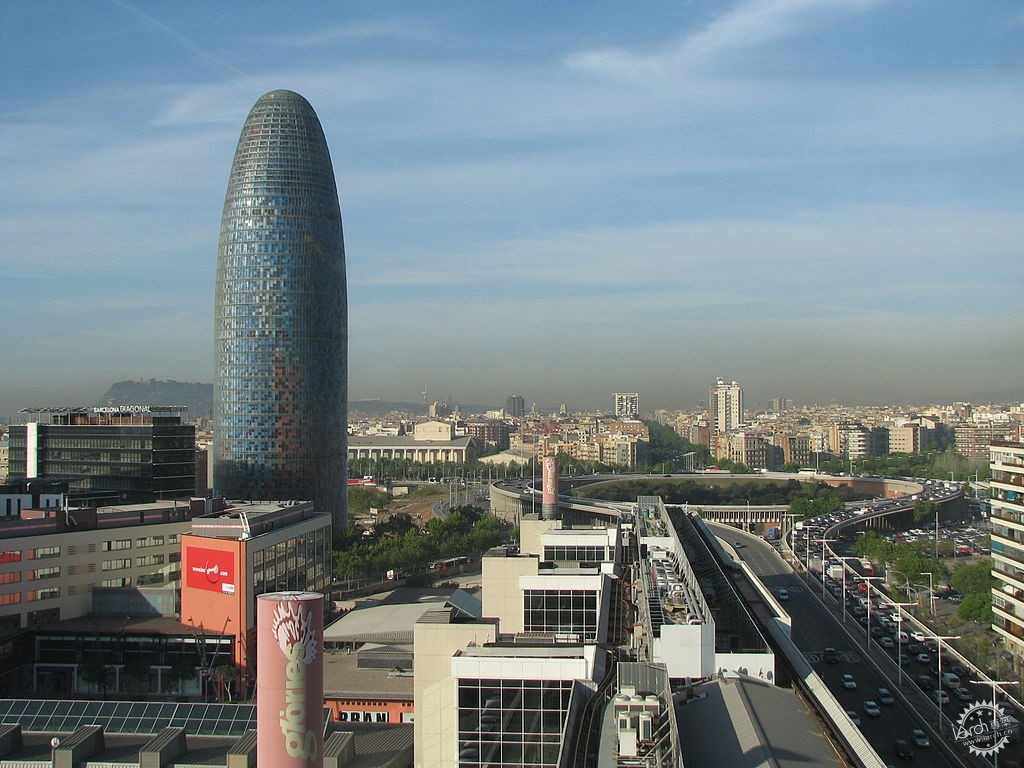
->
{"left": 0, "top": 0, "right": 1024, "bottom": 416}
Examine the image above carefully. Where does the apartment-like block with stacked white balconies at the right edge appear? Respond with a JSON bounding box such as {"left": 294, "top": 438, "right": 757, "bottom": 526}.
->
{"left": 989, "top": 441, "right": 1024, "bottom": 669}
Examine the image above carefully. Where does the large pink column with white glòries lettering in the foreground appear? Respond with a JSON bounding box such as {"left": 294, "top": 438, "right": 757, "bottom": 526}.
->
{"left": 256, "top": 592, "right": 324, "bottom": 768}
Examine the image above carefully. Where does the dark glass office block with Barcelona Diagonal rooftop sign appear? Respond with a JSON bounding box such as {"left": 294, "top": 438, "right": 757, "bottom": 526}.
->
{"left": 8, "top": 406, "right": 196, "bottom": 505}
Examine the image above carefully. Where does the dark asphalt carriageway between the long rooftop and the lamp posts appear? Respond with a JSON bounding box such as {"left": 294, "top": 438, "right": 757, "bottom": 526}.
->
{"left": 709, "top": 523, "right": 970, "bottom": 768}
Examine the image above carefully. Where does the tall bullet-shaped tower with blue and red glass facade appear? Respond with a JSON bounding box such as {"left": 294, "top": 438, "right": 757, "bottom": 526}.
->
{"left": 214, "top": 90, "right": 348, "bottom": 525}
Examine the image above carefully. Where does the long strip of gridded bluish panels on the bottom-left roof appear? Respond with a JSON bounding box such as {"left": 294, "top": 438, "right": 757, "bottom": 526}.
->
{"left": 0, "top": 698, "right": 256, "bottom": 736}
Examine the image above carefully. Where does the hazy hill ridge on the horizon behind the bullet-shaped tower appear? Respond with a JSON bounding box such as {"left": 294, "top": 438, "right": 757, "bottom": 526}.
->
{"left": 95, "top": 379, "right": 495, "bottom": 421}
